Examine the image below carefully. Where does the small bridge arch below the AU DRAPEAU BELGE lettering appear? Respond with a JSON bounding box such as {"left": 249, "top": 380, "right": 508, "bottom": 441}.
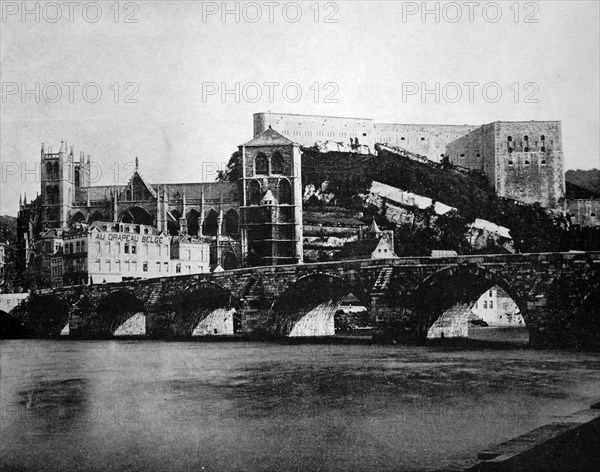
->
{"left": 93, "top": 289, "right": 146, "bottom": 338}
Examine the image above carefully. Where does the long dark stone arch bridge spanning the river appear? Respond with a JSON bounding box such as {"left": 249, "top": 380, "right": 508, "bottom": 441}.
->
{"left": 4, "top": 252, "right": 600, "bottom": 345}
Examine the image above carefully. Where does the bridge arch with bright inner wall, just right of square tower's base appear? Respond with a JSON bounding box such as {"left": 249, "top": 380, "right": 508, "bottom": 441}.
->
{"left": 270, "top": 272, "right": 370, "bottom": 336}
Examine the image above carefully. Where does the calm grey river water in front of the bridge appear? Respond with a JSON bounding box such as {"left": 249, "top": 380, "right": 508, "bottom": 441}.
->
{"left": 0, "top": 340, "right": 600, "bottom": 472}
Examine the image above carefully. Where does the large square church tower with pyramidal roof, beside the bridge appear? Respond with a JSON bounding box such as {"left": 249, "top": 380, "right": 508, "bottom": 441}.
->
{"left": 240, "top": 127, "right": 302, "bottom": 266}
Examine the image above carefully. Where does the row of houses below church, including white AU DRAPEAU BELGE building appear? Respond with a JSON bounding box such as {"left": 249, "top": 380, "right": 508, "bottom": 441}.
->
{"left": 30, "top": 221, "right": 213, "bottom": 287}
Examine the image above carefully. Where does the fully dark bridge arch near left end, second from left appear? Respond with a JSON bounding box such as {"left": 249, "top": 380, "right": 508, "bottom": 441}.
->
{"left": 23, "top": 294, "right": 69, "bottom": 338}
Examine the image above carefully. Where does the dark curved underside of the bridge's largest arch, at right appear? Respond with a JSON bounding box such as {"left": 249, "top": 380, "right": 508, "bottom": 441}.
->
{"left": 409, "top": 264, "right": 529, "bottom": 341}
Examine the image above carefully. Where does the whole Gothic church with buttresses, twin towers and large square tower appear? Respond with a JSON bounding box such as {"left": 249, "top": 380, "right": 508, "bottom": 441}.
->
{"left": 17, "top": 128, "right": 302, "bottom": 278}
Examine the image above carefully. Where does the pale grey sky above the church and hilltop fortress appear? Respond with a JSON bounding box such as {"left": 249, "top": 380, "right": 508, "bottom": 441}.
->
{"left": 0, "top": 0, "right": 600, "bottom": 215}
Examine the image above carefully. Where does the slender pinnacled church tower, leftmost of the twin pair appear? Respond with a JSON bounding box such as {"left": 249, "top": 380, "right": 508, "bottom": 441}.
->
{"left": 40, "top": 141, "right": 74, "bottom": 229}
